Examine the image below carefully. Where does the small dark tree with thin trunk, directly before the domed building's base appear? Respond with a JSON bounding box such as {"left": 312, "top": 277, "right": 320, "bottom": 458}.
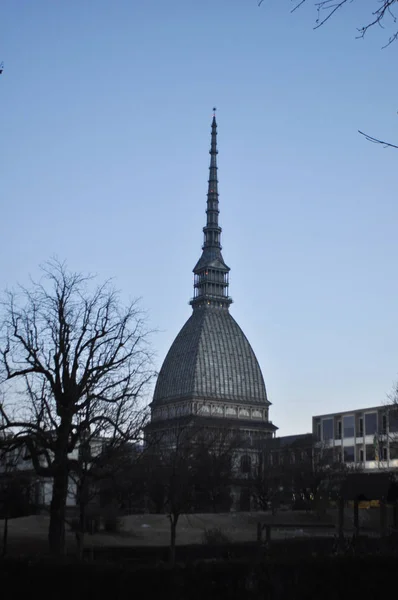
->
{"left": 146, "top": 414, "right": 240, "bottom": 564}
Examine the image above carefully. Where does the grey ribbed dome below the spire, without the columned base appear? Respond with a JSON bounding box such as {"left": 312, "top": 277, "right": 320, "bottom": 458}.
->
{"left": 153, "top": 305, "right": 269, "bottom": 404}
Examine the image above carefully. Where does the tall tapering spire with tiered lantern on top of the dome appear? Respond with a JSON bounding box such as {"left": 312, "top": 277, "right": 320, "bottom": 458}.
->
{"left": 191, "top": 108, "right": 232, "bottom": 308}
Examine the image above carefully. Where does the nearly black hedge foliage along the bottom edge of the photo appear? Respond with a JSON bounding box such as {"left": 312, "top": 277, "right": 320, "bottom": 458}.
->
{"left": 2, "top": 556, "right": 395, "bottom": 600}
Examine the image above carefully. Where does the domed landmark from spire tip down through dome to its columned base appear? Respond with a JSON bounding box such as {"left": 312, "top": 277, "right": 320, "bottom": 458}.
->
{"left": 146, "top": 114, "right": 277, "bottom": 462}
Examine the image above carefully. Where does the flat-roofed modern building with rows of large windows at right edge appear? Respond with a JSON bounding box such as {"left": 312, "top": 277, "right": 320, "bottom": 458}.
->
{"left": 312, "top": 406, "right": 398, "bottom": 470}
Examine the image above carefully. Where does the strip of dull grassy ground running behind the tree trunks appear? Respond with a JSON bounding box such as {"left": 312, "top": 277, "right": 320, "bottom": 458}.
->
{"left": 0, "top": 509, "right": 388, "bottom": 554}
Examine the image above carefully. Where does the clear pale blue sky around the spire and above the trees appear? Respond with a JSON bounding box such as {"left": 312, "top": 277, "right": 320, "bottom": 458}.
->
{"left": 0, "top": 0, "right": 398, "bottom": 434}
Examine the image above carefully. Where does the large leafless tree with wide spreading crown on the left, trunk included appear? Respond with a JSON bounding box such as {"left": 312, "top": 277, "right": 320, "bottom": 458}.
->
{"left": 0, "top": 261, "right": 153, "bottom": 554}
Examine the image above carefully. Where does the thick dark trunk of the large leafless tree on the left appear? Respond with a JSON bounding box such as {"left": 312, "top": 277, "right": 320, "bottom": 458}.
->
{"left": 48, "top": 466, "right": 69, "bottom": 556}
